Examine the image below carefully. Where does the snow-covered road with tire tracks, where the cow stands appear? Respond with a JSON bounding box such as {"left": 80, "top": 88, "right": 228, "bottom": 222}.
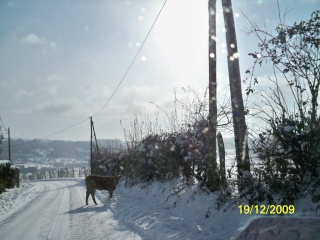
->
{"left": 0, "top": 180, "right": 141, "bottom": 240}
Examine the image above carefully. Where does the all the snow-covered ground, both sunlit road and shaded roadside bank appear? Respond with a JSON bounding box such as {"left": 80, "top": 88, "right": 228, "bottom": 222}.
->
{"left": 0, "top": 179, "right": 318, "bottom": 240}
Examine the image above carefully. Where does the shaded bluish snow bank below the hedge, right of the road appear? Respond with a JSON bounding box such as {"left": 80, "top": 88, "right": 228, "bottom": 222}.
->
{"left": 97, "top": 180, "right": 253, "bottom": 240}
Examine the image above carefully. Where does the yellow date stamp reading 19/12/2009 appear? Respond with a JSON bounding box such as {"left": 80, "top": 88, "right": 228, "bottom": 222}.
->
{"left": 238, "top": 205, "right": 295, "bottom": 215}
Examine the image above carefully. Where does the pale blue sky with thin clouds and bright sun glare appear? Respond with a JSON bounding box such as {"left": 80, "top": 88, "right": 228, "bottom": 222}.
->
{"left": 0, "top": 0, "right": 320, "bottom": 141}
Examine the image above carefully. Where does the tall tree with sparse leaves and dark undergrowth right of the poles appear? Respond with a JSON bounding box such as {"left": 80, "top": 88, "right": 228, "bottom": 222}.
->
{"left": 240, "top": 7, "right": 320, "bottom": 204}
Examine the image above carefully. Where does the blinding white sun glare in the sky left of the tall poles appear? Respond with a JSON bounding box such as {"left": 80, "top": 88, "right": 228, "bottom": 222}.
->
{"left": 154, "top": 0, "right": 208, "bottom": 85}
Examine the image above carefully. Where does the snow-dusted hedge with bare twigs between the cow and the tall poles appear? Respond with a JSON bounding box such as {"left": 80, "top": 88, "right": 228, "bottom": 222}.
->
{"left": 94, "top": 88, "right": 231, "bottom": 199}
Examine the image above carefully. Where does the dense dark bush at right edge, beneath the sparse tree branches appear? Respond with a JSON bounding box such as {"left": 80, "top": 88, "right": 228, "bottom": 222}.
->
{"left": 251, "top": 115, "right": 320, "bottom": 203}
